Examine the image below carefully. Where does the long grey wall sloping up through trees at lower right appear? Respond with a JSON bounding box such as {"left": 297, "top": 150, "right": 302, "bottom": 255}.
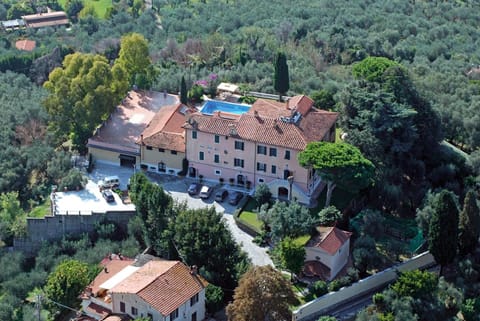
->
{"left": 292, "top": 251, "right": 435, "bottom": 321}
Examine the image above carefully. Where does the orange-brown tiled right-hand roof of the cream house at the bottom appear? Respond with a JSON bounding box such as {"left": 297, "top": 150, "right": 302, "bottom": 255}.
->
{"left": 138, "top": 261, "right": 207, "bottom": 316}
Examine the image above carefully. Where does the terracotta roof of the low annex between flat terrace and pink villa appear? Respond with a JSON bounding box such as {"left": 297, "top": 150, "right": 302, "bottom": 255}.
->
{"left": 137, "top": 104, "right": 192, "bottom": 153}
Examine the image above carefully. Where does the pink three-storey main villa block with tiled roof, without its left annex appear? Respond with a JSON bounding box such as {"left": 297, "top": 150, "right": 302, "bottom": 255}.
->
{"left": 184, "top": 95, "right": 338, "bottom": 205}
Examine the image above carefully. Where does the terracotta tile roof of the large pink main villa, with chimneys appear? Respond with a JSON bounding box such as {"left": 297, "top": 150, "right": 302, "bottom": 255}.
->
{"left": 185, "top": 96, "right": 338, "bottom": 150}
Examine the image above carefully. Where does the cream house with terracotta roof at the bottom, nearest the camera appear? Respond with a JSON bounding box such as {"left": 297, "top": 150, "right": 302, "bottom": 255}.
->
{"left": 82, "top": 258, "right": 207, "bottom": 321}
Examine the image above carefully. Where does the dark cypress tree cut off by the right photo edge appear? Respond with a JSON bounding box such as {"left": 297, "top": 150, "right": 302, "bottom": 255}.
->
{"left": 458, "top": 190, "right": 480, "bottom": 255}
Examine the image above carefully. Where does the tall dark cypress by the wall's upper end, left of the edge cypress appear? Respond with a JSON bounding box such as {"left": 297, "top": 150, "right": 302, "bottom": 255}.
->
{"left": 428, "top": 190, "right": 458, "bottom": 275}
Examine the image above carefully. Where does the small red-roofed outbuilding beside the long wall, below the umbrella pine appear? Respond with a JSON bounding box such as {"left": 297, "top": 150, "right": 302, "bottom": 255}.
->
{"left": 303, "top": 227, "right": 352, "bottom": 281}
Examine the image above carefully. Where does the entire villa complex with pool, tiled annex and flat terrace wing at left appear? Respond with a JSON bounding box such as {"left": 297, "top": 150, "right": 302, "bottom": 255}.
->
{"left": 87, "top": 92, "right": 338, "bottom": 205}
